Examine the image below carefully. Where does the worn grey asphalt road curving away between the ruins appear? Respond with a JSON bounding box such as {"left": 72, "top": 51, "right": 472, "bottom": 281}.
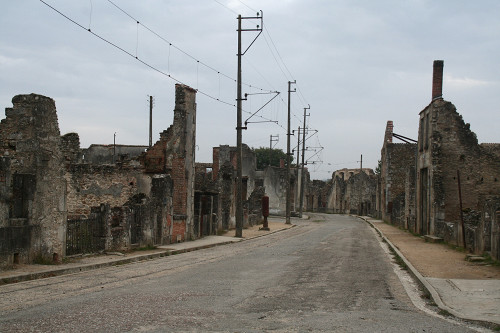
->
{"left": 0, "top": 215, "right": 484, "bottom": 333}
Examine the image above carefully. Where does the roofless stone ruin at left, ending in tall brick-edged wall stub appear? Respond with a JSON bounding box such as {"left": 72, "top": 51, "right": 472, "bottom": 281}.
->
{"left": 0, "top": 85, "right": 199, "bottom": 266}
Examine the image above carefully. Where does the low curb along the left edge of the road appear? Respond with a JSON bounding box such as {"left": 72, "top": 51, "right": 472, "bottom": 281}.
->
{"left": 0, "top": 225, "right": 295, "bottom": 286}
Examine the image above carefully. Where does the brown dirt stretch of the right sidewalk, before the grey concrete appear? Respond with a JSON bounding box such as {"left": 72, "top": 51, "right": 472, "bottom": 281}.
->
{"left": 370, "top": 221, "right": 500, "bottom": 280}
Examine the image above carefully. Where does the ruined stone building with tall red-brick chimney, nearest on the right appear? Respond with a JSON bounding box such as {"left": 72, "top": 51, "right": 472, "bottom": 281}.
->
{"left": 416, "top": 60, "right": 500, "bottom": 258}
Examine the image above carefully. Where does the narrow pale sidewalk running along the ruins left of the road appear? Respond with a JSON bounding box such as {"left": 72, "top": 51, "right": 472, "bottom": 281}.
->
{"left": 0, "top": 218, "right": 294, "bottom": 286}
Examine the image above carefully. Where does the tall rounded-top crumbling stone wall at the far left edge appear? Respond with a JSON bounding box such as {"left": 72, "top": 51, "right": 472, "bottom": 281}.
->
{"left": 0, "top": 94, "right": 66, "bottom": 265}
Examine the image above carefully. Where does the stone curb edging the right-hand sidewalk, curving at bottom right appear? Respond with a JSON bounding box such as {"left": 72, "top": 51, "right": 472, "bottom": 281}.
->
{"left": 358, "top": 216, "right": 498, "bottom": 325}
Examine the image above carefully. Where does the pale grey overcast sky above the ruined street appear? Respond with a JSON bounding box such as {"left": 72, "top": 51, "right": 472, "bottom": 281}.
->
{"left": 0, "top": 0, "right": 500, "bottom": 179}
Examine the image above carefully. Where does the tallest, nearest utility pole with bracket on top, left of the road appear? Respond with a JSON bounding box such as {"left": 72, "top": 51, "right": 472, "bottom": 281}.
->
{"left": 235, "top": 11, "right": 263, "bottom": 238}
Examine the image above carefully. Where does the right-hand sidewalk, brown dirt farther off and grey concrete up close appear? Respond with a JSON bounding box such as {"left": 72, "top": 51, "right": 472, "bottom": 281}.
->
{"left": 360, "top": 217, "right": 500, "bottom": 327}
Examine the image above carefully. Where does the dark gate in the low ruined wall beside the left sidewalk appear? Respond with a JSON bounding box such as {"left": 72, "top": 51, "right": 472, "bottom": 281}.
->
{"left": 66, "top": 217, "right": 106, "bottom": 256}
